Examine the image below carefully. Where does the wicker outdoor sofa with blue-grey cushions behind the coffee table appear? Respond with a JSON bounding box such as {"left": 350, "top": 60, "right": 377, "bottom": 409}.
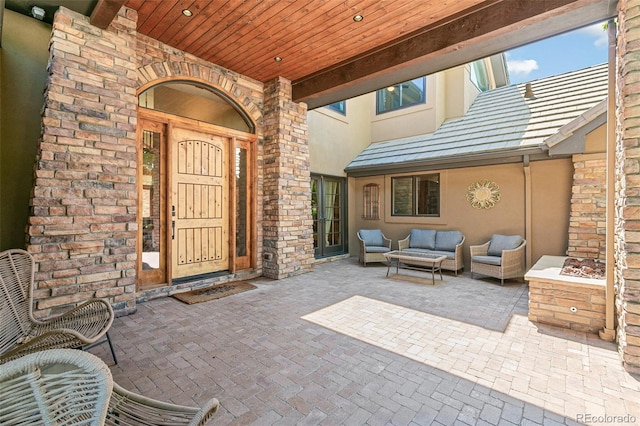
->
{"left": 398, "top": 229, "right": 464, "bottom": 275}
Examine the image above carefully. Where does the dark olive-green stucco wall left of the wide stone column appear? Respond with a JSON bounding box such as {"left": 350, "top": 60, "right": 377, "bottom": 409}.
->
{"left": 0, "top": 9, "right": 51, "bottom": 250}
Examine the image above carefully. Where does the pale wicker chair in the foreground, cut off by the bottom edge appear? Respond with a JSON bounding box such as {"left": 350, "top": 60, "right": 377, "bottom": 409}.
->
{"left": 0, "top": 349, "right": 218, "bottom": 426}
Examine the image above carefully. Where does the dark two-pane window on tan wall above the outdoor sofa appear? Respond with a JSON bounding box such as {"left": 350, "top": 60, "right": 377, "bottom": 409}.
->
{"left": 391, "top": 173, "right": 440, "bottom": 217}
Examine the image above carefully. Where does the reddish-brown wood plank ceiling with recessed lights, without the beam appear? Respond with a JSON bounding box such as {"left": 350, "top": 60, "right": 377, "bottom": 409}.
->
{"left": 125, "top": 0, "right": 487, "bottom": 85}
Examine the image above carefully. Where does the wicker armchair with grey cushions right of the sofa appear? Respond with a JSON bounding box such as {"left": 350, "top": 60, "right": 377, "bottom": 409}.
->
{"left": 469, "top": 234, "right": 527, "bottom": 285}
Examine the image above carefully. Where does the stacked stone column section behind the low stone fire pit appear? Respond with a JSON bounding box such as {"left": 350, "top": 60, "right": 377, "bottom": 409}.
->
{"left": 567, "top": 153, "right": 607, "bottom": 261}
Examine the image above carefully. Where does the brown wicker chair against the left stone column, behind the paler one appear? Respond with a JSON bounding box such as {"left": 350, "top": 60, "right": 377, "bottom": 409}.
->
{"left": 0, "top": 249, "right": 118, "bottom": 364}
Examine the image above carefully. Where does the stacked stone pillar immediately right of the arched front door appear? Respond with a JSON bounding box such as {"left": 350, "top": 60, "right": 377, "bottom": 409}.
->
{"left": 262, "top": 78, "right": 314, "bottom": 279}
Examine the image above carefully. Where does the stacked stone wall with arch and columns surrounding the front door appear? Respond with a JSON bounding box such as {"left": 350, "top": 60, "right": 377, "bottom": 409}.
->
{"left": 27, "top": 7, "right": 313, "bottom": 316}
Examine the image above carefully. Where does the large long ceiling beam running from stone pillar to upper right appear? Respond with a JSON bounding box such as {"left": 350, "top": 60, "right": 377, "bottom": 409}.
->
{"left": 292, "top": 0, "right": 617, "bottom": 109}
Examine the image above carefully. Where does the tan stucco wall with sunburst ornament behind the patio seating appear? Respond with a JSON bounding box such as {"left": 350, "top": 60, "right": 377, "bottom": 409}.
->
{"left": 349, "top": 159, "right": 573, "bottom": 268}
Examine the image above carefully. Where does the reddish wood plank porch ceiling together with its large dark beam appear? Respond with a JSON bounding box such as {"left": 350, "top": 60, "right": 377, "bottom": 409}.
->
{"left": 101, "top": 0, "right": 615, "bottom": 107}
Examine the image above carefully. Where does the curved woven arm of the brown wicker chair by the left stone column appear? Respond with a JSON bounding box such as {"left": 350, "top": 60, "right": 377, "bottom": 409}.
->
{"left": 35, "top": 299, "right": 114, "bottom": 344}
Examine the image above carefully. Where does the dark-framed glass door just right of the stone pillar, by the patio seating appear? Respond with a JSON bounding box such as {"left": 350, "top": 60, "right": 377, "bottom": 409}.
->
{"left": 311, "top": 175, "right": 347, "bottom": 258}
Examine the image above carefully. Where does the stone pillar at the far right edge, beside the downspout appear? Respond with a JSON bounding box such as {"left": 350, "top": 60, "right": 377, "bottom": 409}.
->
{"left": 614, "top": 0, "right": 640, "bottom": 374}
